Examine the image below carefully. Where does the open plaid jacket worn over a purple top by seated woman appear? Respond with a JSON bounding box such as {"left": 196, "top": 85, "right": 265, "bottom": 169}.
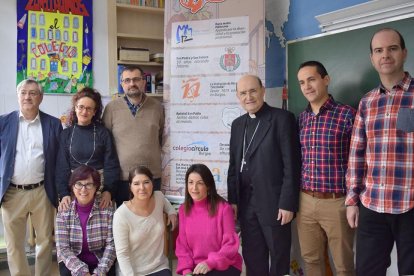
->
{"left": 55, "top": 199, "right": 116, "bottom": 275}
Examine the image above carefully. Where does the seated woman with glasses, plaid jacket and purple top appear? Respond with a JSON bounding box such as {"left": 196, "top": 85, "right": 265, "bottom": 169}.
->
{"left": 55, "top": 165, "right": 116, "bottom": 275}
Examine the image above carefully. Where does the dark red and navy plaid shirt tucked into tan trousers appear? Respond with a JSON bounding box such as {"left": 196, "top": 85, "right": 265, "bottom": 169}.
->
{"left": 299, "top": 96, "right": 355, "bottom": 193}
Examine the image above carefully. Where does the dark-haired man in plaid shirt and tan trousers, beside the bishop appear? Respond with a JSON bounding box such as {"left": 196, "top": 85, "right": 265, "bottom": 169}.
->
{"left": 297, "top": 61, "right": 355, "bottom": 276}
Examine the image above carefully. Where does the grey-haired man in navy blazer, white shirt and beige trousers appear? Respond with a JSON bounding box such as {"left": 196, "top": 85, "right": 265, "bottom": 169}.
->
{"left": 0, "top": 80, "right": 62, "bottom": 276}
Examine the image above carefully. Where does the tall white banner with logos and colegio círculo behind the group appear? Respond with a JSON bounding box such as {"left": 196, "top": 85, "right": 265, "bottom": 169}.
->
{"left": 162, "top": 0, "right": 265, "bottom": 202}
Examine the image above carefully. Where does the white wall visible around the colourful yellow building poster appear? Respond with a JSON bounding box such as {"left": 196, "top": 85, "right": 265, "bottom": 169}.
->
{"left": 0, "top": 0, "right": 109, "bottom": 117}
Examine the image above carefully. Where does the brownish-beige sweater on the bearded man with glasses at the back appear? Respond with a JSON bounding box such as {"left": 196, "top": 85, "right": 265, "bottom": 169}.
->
{"left": 103, "top": 97, "right": 165, "bottom": 181}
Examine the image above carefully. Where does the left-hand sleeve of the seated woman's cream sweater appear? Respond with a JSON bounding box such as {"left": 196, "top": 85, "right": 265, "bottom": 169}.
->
{"left": 113, "top": 205, "right": 134, "bottom": 275}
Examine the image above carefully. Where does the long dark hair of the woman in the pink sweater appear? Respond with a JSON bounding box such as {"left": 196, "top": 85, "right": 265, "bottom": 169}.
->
{"left": 184, "top": 164, "right": 225, "bottom": 217}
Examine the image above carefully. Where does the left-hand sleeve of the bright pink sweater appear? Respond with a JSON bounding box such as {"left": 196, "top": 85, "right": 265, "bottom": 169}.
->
{"left": 175, "top": 205, "right": 195, "bottom": 275}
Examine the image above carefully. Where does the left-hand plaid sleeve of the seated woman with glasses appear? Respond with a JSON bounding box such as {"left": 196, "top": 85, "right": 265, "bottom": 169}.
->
{"left": 55, "top": 209, "right": 89, "bottom": 275}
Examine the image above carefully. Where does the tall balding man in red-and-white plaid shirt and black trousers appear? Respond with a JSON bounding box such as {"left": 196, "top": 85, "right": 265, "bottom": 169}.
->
{"left": 346, "top": 28, "right": 414, "bottom": 276}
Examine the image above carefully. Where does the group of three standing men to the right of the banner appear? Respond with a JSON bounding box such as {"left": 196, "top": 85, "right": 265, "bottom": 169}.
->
{"left": 227, "top": 28, "right": 414, "bottom": 276}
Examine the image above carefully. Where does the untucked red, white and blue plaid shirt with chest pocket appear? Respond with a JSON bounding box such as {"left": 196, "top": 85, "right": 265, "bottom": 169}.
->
{"left": 345, "top": 73, "right": 414, "bottom": 214}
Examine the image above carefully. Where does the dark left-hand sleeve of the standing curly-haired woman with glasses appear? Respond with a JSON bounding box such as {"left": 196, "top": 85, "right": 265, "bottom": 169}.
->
{"left": 55, "top": 129, "right": 71, "bottom": 198}
